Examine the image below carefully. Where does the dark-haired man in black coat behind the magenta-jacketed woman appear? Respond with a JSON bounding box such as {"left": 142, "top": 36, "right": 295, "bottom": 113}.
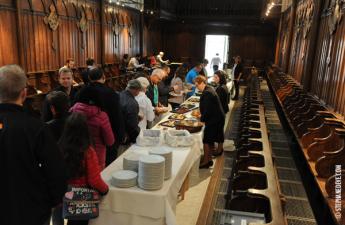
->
{"left": 75, "top": 68, "right": 125, "bottom": 165}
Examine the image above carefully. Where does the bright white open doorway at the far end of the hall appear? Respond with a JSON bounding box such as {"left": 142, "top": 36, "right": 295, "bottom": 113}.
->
{"left": 205, "top": 35, "right": 229, "bottom": 76}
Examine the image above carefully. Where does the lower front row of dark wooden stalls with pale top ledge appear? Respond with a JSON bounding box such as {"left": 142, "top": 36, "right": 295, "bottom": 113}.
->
{"left": 225, "top": 77, "right": 287, "bottom": 225}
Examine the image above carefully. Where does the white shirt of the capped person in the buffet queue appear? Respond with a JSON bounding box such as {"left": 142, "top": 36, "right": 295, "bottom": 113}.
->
{"left": 135, "top": 91, "right": 155, "bottom": 130}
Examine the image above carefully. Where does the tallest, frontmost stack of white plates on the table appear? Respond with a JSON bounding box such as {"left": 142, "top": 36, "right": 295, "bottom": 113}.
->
{"left": 138, "top": 155, "right": 165, "bottom": 190}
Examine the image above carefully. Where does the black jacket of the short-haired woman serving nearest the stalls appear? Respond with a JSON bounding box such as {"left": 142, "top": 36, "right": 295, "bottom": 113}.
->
{"left": 199, "top": 86, "right": 225, "bottom": 125}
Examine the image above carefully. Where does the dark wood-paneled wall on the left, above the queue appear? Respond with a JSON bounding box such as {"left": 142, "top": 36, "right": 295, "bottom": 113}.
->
{"left": 0, "top": 0, "right": 141, "bottom": 72}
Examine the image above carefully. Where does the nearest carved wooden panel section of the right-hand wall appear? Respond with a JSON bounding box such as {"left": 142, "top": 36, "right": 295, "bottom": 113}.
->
{"left": 311, "top": 0, "right": 345, "bottom": 115}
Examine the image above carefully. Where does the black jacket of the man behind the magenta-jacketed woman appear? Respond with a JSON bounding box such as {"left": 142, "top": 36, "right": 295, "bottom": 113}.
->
{"left": 75, "top": 82, "right": 125, "bottom": 143}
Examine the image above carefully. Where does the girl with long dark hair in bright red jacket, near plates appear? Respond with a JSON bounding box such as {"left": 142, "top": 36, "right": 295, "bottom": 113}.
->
{"left": 58, "top": 113, "right": 109, "bottom": 225}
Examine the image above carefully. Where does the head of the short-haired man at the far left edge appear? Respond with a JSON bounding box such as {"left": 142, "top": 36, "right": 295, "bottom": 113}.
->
{"left": 0, "top": 65, "right": 28, "bottom": 102}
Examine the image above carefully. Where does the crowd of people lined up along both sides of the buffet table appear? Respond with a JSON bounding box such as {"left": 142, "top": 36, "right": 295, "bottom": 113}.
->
{"left": 0, "top": 53, "right": 242, "bottom": 225}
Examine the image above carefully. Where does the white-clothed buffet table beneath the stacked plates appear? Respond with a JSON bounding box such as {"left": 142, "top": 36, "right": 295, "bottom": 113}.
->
{"left": 89, "top": 96, "right": 203, "bottom": 225}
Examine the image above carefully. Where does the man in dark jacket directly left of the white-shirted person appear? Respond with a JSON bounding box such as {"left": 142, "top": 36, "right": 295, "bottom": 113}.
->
{"left": 120, "top": 79, "right": 142, "bottom": 144}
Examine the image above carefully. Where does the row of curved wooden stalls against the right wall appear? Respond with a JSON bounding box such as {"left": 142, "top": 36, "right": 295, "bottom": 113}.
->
{"left": 268, "top": 67, "right": 345, "bottom": 225}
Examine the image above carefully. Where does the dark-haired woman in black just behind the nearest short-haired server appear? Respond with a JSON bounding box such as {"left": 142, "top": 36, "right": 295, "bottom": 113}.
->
{"left": 213, "top": 70, "right": 230, "bottom": 114}
